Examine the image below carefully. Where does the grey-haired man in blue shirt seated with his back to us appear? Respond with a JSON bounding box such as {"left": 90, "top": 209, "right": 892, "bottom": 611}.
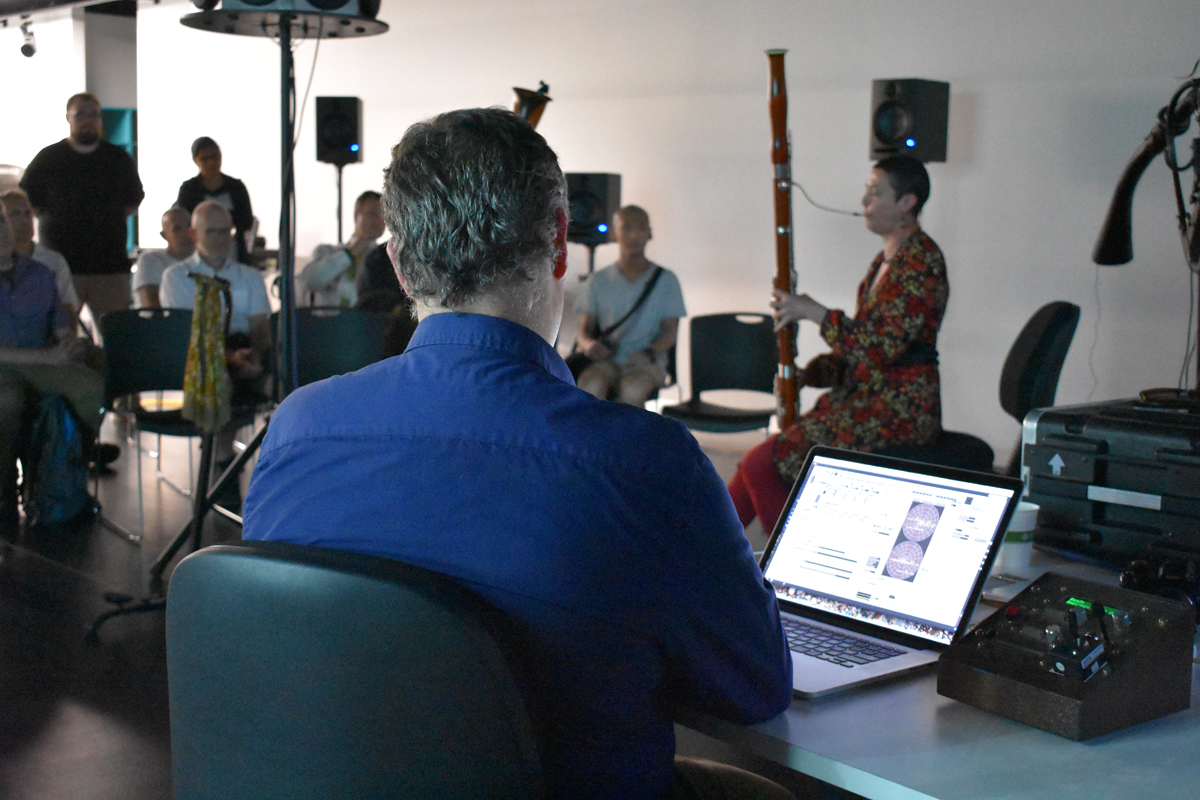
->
{"left": 245, "top": 109, "right": 792, "bottom": 799}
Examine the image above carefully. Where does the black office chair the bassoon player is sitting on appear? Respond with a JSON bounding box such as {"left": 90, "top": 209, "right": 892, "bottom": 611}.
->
{"left": 880, "top": 301, "right": 1079, "bottom": 476}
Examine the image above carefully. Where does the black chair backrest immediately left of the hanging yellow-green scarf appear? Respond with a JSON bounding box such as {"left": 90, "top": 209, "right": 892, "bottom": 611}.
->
{"left": 100, "top": 308, "right": 192, "bottom": 407}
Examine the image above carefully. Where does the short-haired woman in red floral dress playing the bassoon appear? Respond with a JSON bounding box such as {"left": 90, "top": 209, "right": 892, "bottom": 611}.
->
{"left": 730, "top": 156, "right": 950, "bottom": 530}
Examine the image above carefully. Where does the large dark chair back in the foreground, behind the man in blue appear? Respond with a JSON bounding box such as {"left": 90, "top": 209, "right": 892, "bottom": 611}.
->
{"left": 167, "top": 542, "right": 544, "bottom": 800}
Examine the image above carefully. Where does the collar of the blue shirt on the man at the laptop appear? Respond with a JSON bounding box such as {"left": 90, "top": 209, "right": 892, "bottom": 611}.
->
{"left": 407, "top": 312, "right": 575, "bottom": 384}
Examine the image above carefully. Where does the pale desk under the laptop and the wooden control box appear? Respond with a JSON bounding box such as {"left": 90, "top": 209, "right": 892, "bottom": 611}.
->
{"left": 680, "top": 552, "right": 1200, "bottom": 800}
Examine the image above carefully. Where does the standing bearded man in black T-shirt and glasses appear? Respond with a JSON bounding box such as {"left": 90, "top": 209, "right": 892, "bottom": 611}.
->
{"left": 20, "top": 94, "right": 145, "bottom": 319}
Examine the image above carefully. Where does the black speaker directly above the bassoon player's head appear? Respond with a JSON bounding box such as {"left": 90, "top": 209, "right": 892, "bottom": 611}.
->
{"left": 870, "top": 78, "right": 950, "bottom": 162}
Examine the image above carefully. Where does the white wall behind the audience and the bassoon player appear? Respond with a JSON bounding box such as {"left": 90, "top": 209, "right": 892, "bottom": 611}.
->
{"left": 0, "top": 0, "right": 1200, "bottom": 459}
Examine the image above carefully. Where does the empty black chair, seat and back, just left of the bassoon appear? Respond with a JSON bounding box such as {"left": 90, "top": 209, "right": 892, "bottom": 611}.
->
{"left": 662, "top": 313, "right": 779, "bottom": 433}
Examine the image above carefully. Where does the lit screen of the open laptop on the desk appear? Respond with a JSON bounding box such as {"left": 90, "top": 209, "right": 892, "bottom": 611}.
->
{"left": 763, "top": 447, "right": 1019, "bottom": 645}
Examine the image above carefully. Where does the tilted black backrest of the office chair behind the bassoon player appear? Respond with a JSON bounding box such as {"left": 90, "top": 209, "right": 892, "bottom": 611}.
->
{"left": 1000, "top": 301, "right": 1079, "bottom": 422}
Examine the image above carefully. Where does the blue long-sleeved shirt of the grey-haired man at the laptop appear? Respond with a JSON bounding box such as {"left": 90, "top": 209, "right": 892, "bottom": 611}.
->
{"left": 245, "top": 313, "right": 792, "bottom": 798}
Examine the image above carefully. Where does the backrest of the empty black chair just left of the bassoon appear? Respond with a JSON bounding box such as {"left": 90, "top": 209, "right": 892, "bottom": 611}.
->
{"left": 688, "top": 313, "right": 779, "bottom": 398}
